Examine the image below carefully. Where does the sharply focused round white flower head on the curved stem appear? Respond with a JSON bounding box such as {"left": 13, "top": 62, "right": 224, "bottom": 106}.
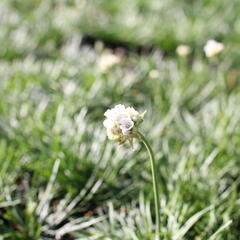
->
{"left": 103, "top": 104, "right": 145, "bottom": 144}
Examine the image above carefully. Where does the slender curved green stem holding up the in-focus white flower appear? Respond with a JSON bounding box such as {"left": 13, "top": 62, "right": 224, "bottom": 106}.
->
{"left": 137, "top": 131, "right": 160, "bottom": 240}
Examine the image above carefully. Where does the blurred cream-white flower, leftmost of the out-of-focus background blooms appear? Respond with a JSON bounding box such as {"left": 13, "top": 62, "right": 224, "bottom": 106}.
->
{"left": 98, "top": 53, "right": 120, "bottom": 72}
